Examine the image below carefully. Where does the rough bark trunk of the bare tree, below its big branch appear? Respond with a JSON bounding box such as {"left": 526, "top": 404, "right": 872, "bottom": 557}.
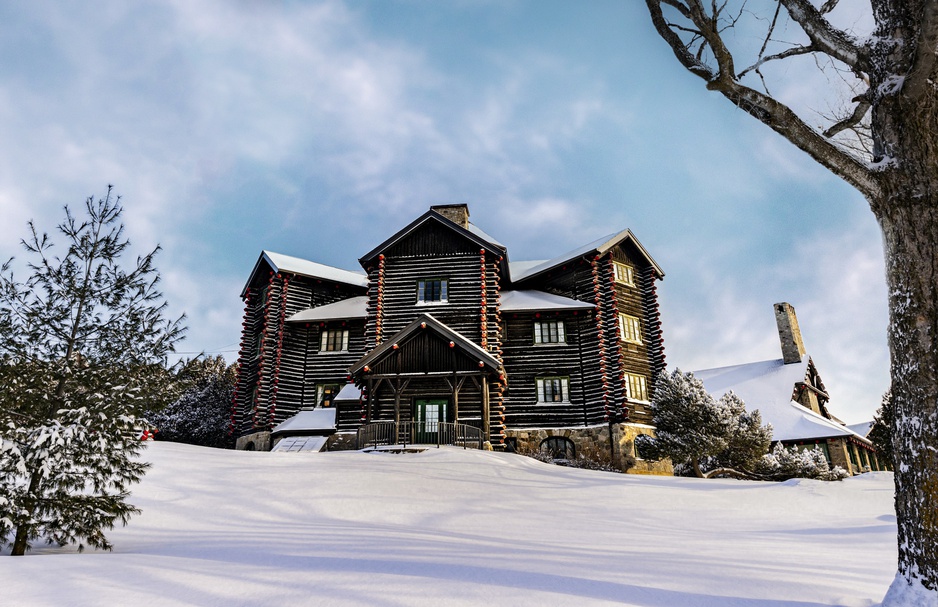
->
{"left": 872, "top": 196, "right": 938, "bottom": 607}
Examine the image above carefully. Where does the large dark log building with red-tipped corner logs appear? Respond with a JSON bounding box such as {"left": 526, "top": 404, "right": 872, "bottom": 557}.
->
{"left": 231, "top": 205, "right": 665, "bottom": 471}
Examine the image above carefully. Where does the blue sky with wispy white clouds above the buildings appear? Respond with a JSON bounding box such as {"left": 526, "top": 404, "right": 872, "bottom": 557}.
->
{"left": 0, "top": 0, "right": 888, "bottom": 422}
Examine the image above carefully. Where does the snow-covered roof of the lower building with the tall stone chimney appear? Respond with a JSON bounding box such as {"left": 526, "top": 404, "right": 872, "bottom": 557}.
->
{"left": 694, "top": 356, "right": 865, "bottom": 441}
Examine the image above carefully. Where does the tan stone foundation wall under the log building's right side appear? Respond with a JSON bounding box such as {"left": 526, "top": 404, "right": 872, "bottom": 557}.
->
{"left": 505, "top": 424, "right": 674, "bottom": 475}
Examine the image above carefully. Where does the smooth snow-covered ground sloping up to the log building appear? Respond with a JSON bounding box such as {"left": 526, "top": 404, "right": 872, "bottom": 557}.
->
{"left": 0, "top": 443, "right": 896, "bottom": 607}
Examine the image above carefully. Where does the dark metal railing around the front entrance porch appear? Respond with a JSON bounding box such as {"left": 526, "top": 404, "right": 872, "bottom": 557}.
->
{"left": 356, "top": 421, "right": 485, "bottom": 449}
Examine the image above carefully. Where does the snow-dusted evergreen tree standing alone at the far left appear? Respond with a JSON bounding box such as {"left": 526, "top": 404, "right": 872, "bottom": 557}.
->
{"left": 0, "top": 186, "right": 185, "bottom": 555}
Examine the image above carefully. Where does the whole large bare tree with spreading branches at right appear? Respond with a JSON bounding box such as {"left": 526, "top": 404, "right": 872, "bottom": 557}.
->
{"left": 645, "top": 0, "right": 938, "bottom": 605}
